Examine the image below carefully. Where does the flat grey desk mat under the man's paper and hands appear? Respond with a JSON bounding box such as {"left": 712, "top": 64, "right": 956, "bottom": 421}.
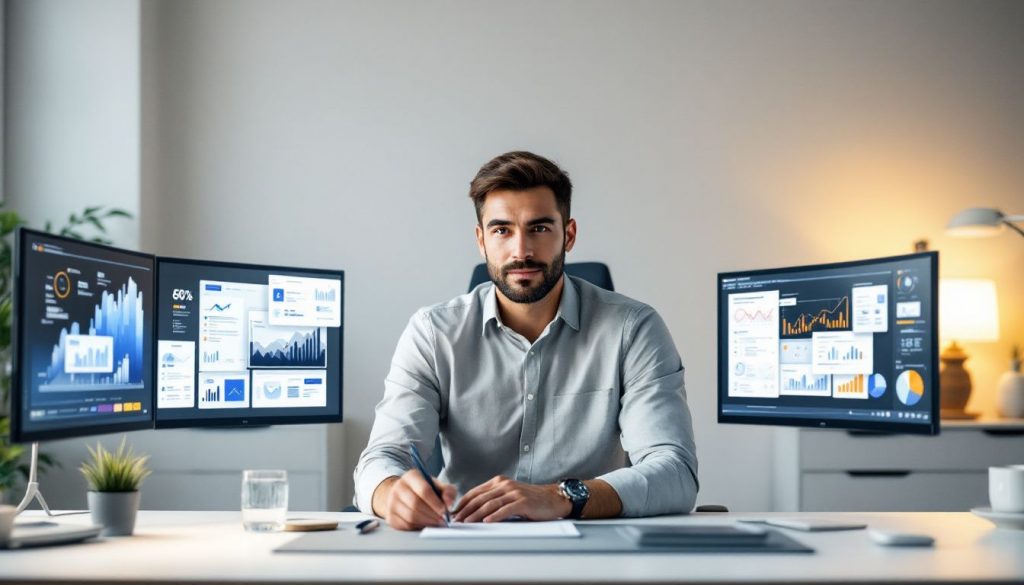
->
{"left": 274, "top": 525, "right": 814, "bottom": 554}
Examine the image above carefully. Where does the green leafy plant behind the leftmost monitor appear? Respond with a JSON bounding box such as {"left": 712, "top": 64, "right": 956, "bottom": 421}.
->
{"left": 0, "top": 203, "right": 132, "bottom": 501}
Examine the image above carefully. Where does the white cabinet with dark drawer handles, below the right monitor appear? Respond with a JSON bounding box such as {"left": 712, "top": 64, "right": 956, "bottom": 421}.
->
{"left": 774, "top": 421, "right": 1024, "bottom": 511}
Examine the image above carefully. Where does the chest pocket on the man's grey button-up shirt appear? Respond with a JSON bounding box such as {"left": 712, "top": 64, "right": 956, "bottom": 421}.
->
{"left": 552, "top": 386, "right": 618, "bottom": 471}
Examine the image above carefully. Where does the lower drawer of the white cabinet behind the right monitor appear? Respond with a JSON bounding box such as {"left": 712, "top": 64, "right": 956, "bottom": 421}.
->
{"left": 800, "top": 471, "right": 988, "bottom": 512}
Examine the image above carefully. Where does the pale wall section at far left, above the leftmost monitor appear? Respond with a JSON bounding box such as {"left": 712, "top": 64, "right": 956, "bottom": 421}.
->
{"left": 3, "top": 0, "right": 139, "bottom": 247}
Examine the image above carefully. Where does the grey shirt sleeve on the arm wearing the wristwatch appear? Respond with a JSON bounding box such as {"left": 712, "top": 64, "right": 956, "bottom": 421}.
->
{"left": 598, "top": 305, "right": 698, "bottom": 516}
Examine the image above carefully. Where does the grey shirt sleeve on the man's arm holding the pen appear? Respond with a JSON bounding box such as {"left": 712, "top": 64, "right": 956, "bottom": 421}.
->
{"left": 352, "top": 310, "right": 440, "bottom": 513}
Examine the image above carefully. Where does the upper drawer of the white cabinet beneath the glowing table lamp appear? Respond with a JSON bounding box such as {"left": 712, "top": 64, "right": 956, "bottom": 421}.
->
{"left": 799, "top": 429, "right": 1024, "bottom": 471}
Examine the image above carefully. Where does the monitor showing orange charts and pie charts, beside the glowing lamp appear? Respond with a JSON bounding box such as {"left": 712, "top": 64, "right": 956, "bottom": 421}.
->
{"left": 718, "top": 252, "right": 939, "bottom": 434}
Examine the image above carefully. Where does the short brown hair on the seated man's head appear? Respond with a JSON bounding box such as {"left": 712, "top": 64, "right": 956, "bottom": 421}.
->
{"left": 469, "top": 151, "right": 572, "bottom": 223}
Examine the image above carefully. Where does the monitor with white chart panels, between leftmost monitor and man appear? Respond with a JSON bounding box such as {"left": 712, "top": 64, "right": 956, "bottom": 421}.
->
{"left": 156, "top": 258, "right": 345, "bottom": 427}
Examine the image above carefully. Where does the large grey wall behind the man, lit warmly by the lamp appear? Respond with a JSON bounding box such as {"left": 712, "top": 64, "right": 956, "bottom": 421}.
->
{"left": 8, "top": 0, "right": 1024, "bottom": 510}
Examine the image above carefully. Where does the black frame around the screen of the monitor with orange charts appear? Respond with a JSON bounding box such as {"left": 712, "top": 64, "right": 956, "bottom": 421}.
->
{"left": 715, "top": 251, "right": 940, "bottom": 435}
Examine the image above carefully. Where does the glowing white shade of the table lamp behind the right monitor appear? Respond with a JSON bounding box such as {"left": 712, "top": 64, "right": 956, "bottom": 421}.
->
{"left": 939, "top": 279, "right": 999, "bottom": 341}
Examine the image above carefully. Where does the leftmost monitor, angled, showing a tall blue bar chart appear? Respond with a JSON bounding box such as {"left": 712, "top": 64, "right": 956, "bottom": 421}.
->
{"left": 11, "top": 229, "right": 155, "bottom": 442}
